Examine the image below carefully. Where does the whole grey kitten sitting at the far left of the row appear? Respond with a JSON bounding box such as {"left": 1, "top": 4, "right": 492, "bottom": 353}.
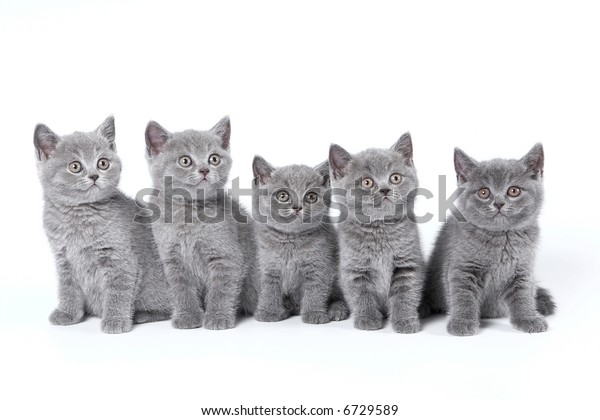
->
{"left": 34, "top": 117, "right": 171, "bottom": 333}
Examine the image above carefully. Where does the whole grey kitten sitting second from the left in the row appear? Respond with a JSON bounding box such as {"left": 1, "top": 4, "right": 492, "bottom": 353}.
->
{"left": 146, "top": 117, "right": 258, "bottom": 330}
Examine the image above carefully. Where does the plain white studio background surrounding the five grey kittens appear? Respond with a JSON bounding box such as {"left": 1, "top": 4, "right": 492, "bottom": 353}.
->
{"left": 0, "top": 1, "right": 600, "bottom": 419}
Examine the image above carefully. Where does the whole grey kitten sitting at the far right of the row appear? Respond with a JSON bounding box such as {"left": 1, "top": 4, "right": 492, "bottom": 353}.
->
{"left": 422, "top": 144, "right": 555, "bottom": 335}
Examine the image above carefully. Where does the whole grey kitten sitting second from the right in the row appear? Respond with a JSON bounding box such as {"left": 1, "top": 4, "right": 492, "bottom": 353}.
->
{"left": 329, "top": 133, "right": 424, "bottom": 333}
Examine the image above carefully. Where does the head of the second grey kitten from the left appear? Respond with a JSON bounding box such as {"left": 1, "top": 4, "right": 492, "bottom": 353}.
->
{"left": 146, "top": 117, "right": 232, "bottom": 199}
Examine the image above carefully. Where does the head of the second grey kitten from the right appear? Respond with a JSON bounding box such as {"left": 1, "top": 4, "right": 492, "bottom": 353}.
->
{"left": 329, "top": 133, "right": 418, "bottom": 222}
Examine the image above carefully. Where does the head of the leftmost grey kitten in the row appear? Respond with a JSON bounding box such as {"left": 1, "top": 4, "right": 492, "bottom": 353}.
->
{"left": 33, "top": 116, "right": 121, "bottom": 205}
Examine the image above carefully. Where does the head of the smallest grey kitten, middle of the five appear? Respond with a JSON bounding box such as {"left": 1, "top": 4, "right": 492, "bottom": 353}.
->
{"left": 252, "top": 156, "right": 329, "bottom": 232}
